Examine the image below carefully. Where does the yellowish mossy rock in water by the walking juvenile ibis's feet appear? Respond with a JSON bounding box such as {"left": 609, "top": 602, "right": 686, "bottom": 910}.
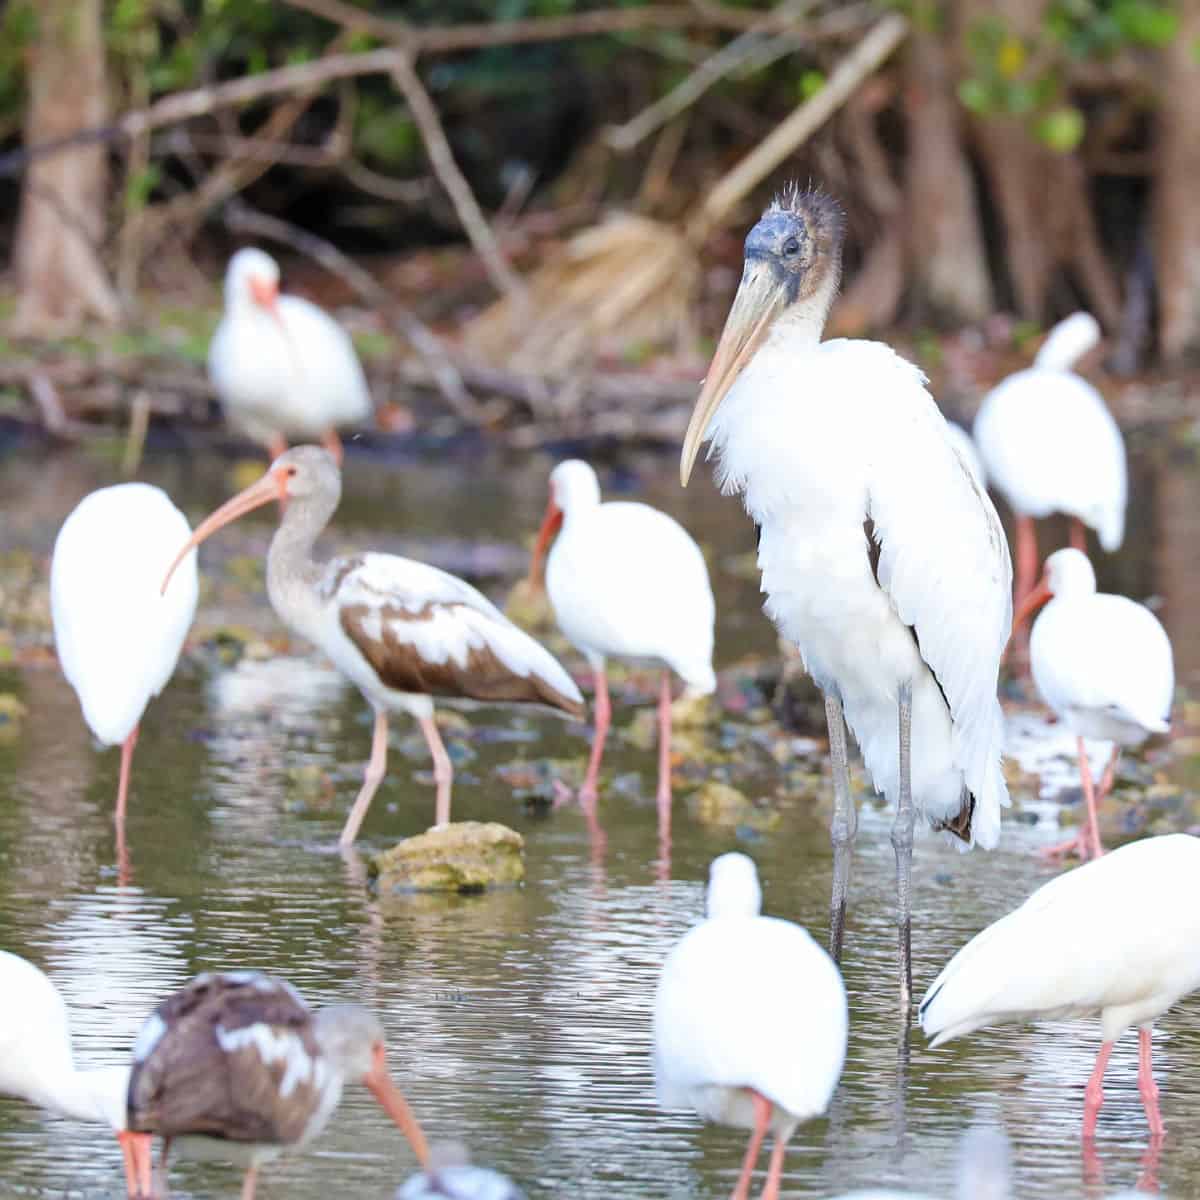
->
{"left": 371, "top": 821, "right": 524, "bottom": 892}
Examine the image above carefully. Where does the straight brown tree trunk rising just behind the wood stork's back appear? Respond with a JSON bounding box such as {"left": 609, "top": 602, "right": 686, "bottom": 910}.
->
{"left": 904, "top": 23, "right": 992, "bottom": 324}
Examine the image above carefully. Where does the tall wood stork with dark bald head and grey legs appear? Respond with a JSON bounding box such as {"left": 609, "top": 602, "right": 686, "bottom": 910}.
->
{"left": 680, "top": 188, "right": 1012, "bottom": 1015}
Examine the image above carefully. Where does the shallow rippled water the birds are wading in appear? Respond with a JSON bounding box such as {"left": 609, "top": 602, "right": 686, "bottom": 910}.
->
{"left": 0, "top": 445, "right": 1200, "bottom": 1200}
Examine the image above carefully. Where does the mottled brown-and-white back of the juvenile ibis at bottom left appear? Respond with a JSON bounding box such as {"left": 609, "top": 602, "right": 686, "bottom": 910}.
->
{"left": 127, "top": 971, "right": 324, "bottom": 1145}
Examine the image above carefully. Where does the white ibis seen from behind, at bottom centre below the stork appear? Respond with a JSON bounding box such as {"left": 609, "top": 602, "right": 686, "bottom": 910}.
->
{"left": 654, "top": 853, "right": 847, "bottom": 1200}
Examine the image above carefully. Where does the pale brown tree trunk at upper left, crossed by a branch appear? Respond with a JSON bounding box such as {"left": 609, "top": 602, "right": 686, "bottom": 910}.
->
{"left": 14, "top": 0, "right": 120, "bottom": 335}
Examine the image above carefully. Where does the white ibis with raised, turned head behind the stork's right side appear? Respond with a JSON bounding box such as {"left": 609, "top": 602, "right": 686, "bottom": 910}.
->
{"left": 974, "top": 312, "right": 1128, "bottom": 619}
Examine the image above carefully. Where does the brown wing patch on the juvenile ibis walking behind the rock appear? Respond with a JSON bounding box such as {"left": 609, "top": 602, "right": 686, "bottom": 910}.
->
{"left": 341, "top": 604, "right": 583, "bottom": 718}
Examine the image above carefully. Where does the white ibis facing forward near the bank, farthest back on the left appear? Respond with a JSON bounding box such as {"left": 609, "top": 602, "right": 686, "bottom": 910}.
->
{"left": 209, "top": 247, "right": 371, "bottom": 462}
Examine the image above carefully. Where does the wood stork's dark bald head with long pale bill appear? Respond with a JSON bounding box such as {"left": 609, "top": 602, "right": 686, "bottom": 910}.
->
{"left": 679, "top": 185, "right": 845, "bottom": 486}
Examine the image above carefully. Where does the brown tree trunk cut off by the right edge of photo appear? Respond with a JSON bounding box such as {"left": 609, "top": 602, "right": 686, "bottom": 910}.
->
{"left": 1154, "top": 0, "right": 1200, "bottom": 360}
